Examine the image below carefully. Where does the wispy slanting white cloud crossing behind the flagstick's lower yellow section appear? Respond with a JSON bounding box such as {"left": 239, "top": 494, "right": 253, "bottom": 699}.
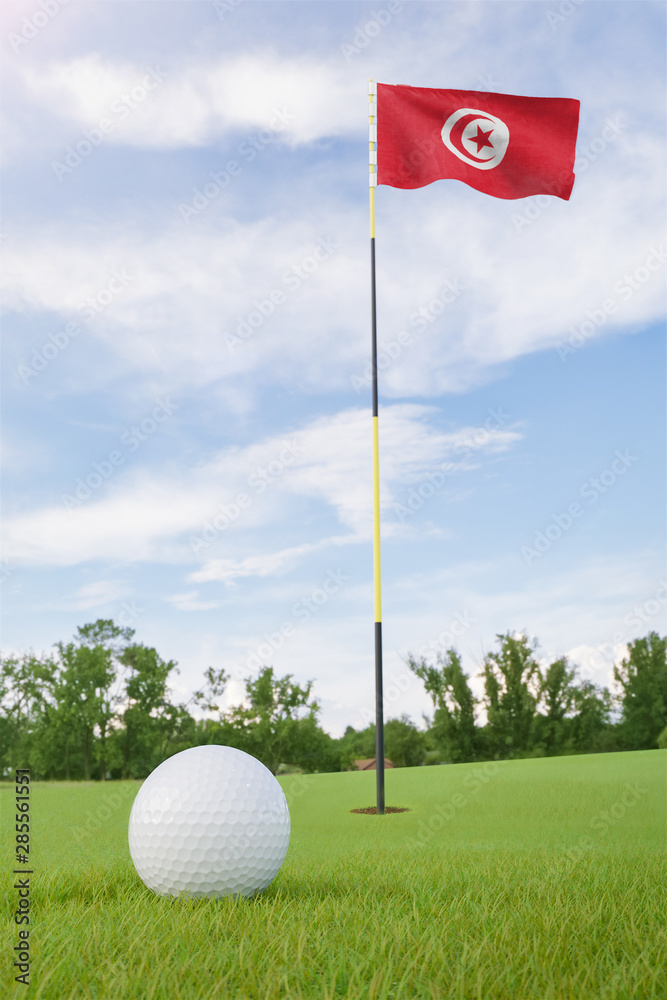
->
{"left": 4, "top": 405, "right": 521, "bottom": 568}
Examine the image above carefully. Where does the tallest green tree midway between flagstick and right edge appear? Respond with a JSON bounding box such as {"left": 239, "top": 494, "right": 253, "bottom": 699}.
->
{"left": 480, "top": 632, "right": 540, "bottom": 759}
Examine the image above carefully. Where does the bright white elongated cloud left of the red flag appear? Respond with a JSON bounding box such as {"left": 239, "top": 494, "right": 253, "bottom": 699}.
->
{"left": 9, "top": 51, "right": 367, "bottom": 150}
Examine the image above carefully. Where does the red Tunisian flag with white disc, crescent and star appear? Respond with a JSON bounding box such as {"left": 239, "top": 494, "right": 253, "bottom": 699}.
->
{"left": 376, "top": 83, "right": 579, "bottom": 201}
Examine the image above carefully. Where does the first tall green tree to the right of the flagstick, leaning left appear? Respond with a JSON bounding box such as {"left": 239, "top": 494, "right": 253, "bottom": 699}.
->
{"left": 408, "top": 649, "right": 480, "bottom": 763}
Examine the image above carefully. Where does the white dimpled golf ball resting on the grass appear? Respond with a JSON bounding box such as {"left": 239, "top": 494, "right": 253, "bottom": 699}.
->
{"left": 129, "top": 745, "right": 290, "bottom": 897}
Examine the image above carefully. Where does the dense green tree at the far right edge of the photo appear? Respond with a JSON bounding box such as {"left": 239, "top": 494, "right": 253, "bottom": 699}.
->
{"left": 614, "top": 632, "right": 667, "bottom": 750}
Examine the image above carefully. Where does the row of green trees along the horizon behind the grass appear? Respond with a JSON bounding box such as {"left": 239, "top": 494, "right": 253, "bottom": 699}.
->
{"left": 0, "top": 619, "right": 667, "bottom": 781}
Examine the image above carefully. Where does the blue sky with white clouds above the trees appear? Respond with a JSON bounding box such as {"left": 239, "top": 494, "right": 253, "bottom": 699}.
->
{"left": 0, "top": 0, "right": 667, "bottom": 736}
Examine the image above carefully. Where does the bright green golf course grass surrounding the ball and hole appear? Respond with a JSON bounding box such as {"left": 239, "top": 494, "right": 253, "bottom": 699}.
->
{"left": 0, "top": 750, "right": 667, "bottom": 1000}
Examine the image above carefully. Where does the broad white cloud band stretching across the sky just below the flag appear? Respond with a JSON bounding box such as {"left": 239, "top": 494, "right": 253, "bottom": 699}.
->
{"left": 4, "top": 126, "right": 666, "bottom": 397}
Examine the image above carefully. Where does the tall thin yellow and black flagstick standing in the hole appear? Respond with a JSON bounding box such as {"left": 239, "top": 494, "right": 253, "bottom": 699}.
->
{"left": 369, "top": 81, "right": 384, "bottom": 816}
